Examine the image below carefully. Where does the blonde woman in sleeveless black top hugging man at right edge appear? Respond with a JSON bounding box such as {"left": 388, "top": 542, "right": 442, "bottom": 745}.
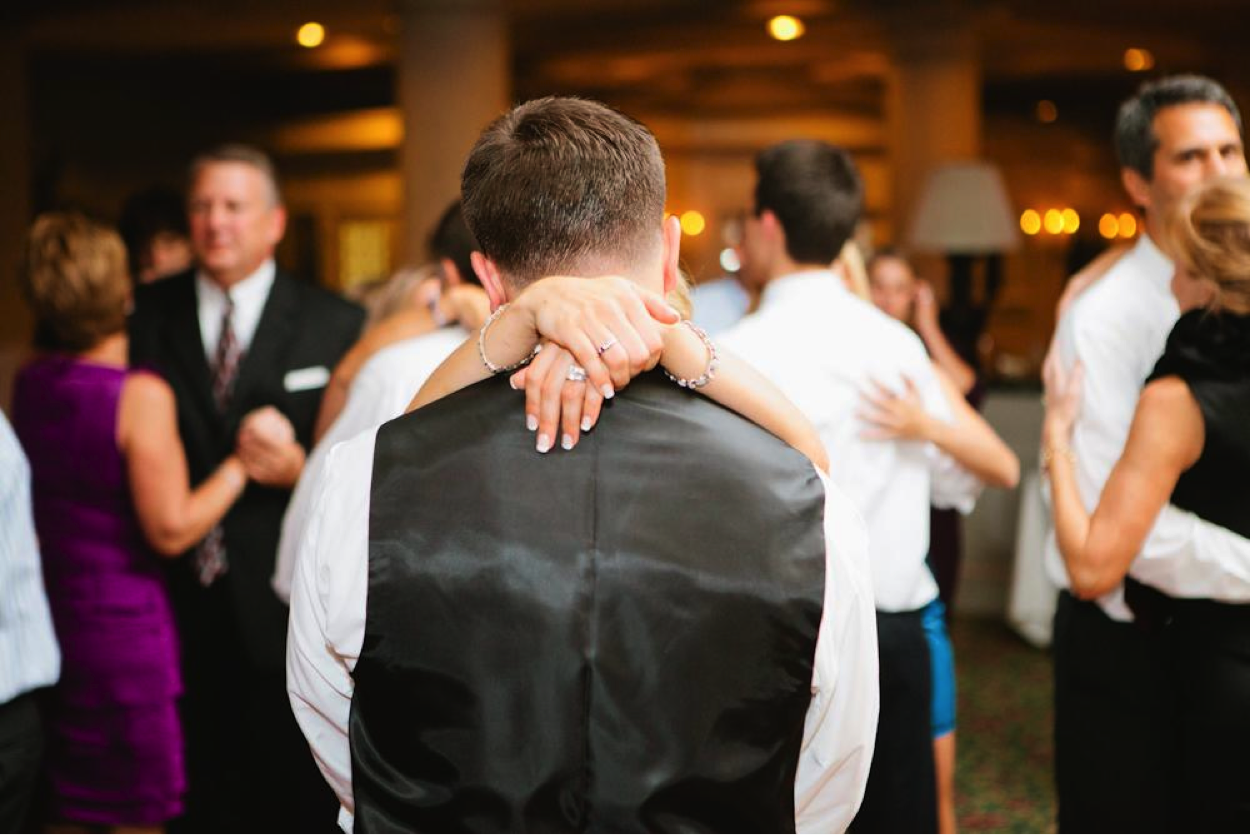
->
{"left": 1043, "top": 179, "right": 1250, "bottom": 831}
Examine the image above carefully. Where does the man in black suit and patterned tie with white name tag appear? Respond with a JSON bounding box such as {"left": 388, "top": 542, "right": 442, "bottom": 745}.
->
{"left": 130, "top": 145, "right": 364, "bottom": 833}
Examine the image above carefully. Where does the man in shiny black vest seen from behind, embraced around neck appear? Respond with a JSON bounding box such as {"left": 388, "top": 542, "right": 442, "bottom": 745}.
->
{"left": 289, "top": 99, "right": 876, "bottom": 833}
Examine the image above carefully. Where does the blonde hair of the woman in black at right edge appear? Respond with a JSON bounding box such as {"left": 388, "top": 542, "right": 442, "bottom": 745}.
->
{"left": 1165, "top": 178, "right": 1250, "bottom": 315}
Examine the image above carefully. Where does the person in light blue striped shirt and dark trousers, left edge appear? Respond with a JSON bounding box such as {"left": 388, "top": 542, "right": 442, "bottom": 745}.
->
{"left": 0, "top": 413, "right": 61, "bottom": 833}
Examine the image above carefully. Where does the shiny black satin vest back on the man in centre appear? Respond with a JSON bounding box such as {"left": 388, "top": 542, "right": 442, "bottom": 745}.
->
{"left": 350, "top": 374, "right": 825, "bottom": 833}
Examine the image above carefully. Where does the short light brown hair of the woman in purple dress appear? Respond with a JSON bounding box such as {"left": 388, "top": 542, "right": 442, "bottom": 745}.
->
{"left": 21, "top": 213, "right": 130, "bottom": 353}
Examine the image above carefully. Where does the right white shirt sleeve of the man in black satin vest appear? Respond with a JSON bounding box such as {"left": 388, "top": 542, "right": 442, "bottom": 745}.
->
{"left": 794, "top": 475, "right": 880, "bottom": 835}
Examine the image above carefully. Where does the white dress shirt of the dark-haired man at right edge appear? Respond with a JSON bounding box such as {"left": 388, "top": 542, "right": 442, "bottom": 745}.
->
{"left": 1046, "top": 234, "right": 1250, "bottom": 612}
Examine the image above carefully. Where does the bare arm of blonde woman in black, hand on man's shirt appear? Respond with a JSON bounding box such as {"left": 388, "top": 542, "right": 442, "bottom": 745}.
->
{"left": 1043, "top": 378, "right": 1205, "bottom": 599}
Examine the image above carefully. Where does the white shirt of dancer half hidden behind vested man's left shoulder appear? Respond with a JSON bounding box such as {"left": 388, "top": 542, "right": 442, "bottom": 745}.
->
{"left": 273, "top": 325, "right": 469, "bottom": 601}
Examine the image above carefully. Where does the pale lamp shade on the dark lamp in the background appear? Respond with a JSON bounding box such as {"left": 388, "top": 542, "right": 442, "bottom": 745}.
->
{"left": 910, "top": 160, "right": 1020, "bottom": 255}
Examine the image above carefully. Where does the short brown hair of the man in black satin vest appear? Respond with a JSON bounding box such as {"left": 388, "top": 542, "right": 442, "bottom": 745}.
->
{"left": 460, "top": 98, "right": 665, "bottom": 288}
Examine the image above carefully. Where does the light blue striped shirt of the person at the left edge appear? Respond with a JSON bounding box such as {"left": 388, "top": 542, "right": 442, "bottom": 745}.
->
{"left": 0, "top": 413, "right": 61, "bottom": 705}
